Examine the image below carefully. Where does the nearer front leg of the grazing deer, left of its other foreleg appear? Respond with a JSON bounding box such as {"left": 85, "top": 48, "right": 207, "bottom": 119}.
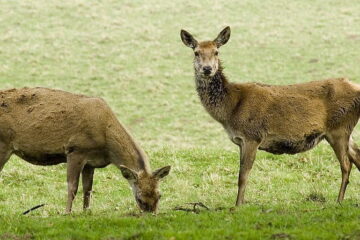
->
{"left": 66, "top": 152, "right": 85, "bottom": 213}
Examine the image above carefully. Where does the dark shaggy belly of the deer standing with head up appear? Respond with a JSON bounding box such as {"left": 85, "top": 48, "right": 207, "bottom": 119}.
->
{"left": 259, "top": 133, "right": 325, "bottom": 154}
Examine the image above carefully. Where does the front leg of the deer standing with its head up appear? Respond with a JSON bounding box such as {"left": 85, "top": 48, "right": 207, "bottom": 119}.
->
{"left": 236, "top": 141, "right": 259, "bottom": 206}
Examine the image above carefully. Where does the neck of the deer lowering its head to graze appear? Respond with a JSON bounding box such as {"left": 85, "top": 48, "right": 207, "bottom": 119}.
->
{"left": 106, "top": 120, "right": 151, "bottom": 173}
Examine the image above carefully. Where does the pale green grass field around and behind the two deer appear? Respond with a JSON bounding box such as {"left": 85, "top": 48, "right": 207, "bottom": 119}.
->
{"left": 0, "top": 0, "right": 360, "bottom": 240}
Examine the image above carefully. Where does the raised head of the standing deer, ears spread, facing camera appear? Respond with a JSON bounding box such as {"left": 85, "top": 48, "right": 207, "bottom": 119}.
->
{"left": 180, "top": 27, "right": 230, "bottom": 77}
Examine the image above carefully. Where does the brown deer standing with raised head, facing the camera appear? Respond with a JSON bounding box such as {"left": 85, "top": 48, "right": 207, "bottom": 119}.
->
{"left": 180, "top": 27, "right": 360, "bottom": 205}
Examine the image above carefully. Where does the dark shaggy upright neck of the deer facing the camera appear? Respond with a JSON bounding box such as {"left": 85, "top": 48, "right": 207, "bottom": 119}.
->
{"left": 195, "top": 64, "right": 230, "bottom": 123}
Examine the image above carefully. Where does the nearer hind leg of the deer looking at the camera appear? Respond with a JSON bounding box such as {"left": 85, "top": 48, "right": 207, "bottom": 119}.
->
{"left": 327, "top": 134, "right": 352, "bottom": 203}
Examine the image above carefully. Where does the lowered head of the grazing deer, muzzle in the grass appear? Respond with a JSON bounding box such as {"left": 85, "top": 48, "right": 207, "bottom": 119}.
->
{"left": 120, "top": 165, "right": 170, "bottom": 212}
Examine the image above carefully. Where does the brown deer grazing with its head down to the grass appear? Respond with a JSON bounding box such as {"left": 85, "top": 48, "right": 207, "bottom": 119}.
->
{"left": 0, "top": 88, "right": 170, "bottom": 213}
